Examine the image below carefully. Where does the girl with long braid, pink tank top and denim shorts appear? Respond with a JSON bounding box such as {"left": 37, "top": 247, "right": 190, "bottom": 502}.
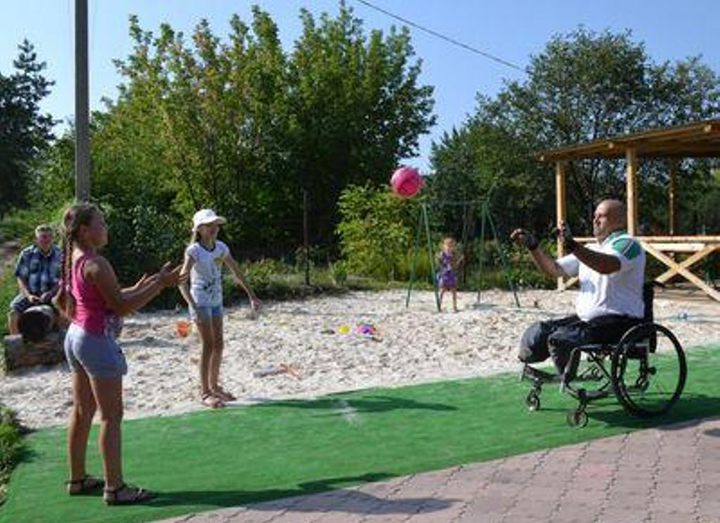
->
{"left": 56, "top": 203, "right": 186, "bottom": 505}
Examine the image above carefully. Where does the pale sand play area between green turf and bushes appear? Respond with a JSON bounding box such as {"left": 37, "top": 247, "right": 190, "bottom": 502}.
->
{"left": 0, "top": 290, "right": 720, "bottom": 427}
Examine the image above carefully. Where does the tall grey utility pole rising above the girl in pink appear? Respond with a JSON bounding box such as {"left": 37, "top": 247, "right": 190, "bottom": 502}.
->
{"left": 75, "top": 0, "right": 90, "bottom": 202}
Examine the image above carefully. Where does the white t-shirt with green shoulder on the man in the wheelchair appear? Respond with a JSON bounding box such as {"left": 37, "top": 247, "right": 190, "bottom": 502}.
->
{"left": 557, "top": 231, "right": 645, "bottom": 321}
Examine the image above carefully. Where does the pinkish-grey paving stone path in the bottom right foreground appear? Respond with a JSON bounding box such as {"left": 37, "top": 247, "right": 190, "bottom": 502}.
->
{"left": 156, "top": 418, "right": 720, "bottom": 523}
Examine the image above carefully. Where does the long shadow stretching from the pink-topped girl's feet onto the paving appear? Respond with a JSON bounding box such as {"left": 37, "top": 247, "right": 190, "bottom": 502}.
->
{"left": 148, "top": 472, "right": 457, "bottom": 514}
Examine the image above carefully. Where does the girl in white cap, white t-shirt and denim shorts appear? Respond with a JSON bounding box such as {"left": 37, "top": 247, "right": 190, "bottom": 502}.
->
{"left": 180, "top": 209, "right": 262, "bottom": 409}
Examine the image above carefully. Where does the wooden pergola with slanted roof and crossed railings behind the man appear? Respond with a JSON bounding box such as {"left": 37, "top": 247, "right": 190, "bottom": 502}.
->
{"left": 538, "top": 120, "right": 720, "bottom": 301}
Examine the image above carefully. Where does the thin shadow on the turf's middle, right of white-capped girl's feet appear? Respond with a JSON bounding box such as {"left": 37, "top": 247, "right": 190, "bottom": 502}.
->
{"left": 255, "top": 395, "right": 458, "bottom": 416}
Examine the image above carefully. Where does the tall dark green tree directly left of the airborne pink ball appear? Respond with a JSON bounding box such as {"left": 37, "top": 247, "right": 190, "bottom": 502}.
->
{"left": 289, "top": 3, "right": 435, "bottom": 242}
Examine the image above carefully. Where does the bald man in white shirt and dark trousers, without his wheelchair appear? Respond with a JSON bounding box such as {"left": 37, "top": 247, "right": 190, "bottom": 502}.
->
{"left": 511, "top": 199, "right": 645, "bottom": 383}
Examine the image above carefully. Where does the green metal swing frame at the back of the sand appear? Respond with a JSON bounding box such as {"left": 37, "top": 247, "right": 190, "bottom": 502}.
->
{"left": 405, "top": 189, "right": 520, "bottom": 312}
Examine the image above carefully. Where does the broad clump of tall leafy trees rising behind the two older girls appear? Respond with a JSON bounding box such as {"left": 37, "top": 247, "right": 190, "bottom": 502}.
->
{"left": 38, "top": 4, "right": 434, "bottom": 260}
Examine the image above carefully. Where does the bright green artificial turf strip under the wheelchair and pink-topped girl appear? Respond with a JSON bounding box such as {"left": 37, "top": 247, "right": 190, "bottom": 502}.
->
{"left": 0, "top": 347, "right": 720, "bottom": 523}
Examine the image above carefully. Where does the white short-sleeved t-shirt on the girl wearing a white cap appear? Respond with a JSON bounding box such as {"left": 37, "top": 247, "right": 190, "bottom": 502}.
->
{"left": 185, "top": 240, "right": 230, "bottom": 307}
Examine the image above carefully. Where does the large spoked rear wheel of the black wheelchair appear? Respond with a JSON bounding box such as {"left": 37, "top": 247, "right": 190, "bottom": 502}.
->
{"left": 611, "top": 323, "right": 687, "bottom": 417}
